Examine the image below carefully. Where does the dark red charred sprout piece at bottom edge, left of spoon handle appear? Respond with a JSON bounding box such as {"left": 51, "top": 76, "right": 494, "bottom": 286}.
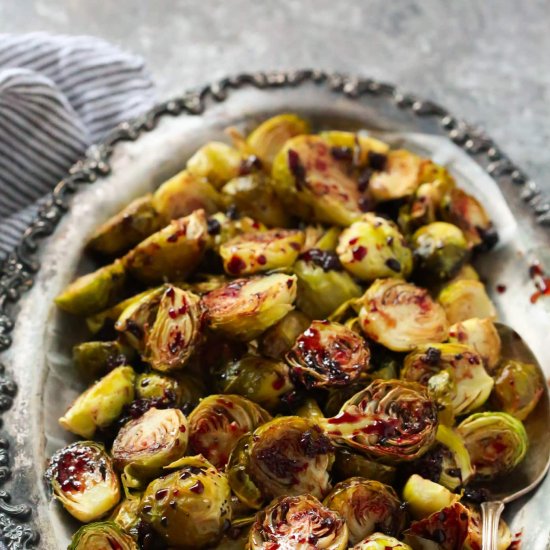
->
{"left": 404, "top": 502, "right": 470, "bottom": 550}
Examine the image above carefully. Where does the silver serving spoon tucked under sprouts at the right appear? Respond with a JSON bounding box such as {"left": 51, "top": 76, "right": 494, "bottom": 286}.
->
{"left": 481, "top": 323, "right": 550, "bottom": 550}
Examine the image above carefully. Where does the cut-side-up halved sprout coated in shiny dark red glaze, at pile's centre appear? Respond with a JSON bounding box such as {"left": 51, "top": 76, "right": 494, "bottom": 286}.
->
{"left": 286, "top": 321, "right": 370, "bottom": 389}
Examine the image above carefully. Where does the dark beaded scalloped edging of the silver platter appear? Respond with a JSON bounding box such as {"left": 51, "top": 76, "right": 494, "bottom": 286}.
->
{"left": 0, "top": 70, "right": 550, "bottom": 550}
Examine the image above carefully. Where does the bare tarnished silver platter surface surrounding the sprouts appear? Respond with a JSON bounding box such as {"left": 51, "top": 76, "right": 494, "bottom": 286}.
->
{"left": 0, "top": 72, "right": 550, "bottom": 550}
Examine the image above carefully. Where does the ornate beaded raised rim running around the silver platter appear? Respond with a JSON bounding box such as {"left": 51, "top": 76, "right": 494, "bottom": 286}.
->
{"left": 0, "top": 70, "right": 550, "bottom": 550}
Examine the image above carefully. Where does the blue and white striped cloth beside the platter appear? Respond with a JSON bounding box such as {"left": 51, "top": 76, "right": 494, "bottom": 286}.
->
{"left": 0, "top": 33, "right": 155, "bottom": 266}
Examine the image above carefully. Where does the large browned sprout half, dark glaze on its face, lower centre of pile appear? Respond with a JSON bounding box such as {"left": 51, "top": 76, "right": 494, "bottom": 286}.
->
{"left": 227, "top": 416, "right": 334, "bottom": 508}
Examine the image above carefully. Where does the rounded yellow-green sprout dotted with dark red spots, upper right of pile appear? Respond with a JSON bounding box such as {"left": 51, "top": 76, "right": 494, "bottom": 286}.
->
{"left": 336, "top": 213, "right": 413, "bottom": 281}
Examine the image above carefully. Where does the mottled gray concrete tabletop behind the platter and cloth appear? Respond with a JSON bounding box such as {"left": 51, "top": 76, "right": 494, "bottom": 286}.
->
{"left": 0, "top": 0, "right": 550, "bottom": 190}
